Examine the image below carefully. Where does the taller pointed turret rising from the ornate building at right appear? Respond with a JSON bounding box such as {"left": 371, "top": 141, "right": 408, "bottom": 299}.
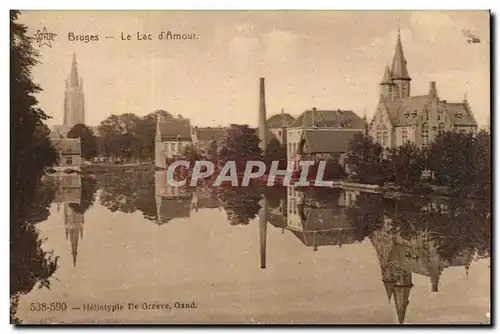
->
{"left": 391, "top": 28, "right": 411, "bottom": 100}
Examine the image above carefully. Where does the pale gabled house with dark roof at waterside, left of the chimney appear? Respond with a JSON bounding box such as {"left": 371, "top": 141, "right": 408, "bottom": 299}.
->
{"left": 155, "top": 115, "right": 191, "bottom": 169}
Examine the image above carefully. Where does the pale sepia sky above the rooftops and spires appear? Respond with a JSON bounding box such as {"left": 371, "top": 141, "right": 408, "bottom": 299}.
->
{"left": 20, "top": 11, "right": 490, "bottom": 127}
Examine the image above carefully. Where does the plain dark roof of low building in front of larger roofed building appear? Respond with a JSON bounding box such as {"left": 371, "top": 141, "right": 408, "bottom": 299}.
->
{"left": 302, "top": 129, "right": 360, "bottom": 153}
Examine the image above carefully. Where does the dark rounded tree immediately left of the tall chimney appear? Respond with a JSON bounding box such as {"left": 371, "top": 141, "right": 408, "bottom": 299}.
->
{"left": 219, "top": 124, "right": 262, "bottom": 173}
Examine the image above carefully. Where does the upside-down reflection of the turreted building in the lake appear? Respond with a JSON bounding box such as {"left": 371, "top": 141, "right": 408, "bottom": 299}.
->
{"left": 371, "top": 218, "right": 473, "bottom": 324}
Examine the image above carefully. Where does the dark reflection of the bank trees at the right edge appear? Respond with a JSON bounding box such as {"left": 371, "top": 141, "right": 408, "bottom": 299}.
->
{"left": 347, "top": 193, "right": 491, "bottom": 260}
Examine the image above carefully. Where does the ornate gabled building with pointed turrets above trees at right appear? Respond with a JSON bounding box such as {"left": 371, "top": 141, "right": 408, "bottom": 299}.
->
{"left": 369, "top": 31, "right": 477, "bottom": 148}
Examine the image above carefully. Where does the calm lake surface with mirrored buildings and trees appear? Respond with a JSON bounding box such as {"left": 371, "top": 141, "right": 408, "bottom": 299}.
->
{"left": 13, "top": 172, "right": 490, "bottom": 324}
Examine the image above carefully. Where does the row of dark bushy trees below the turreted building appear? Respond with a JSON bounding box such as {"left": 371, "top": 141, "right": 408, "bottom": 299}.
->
{"left": 346, "top": 130, "right": 491, "bottom": 198}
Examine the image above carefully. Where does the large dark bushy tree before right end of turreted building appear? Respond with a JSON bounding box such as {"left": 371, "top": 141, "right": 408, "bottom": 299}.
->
{"left": 428, "top": 132, "right": 476, "bottom": 196}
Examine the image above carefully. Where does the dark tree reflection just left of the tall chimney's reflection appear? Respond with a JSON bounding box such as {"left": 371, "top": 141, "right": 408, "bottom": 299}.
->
{"left": 219, "top": 187, "right": 261, "bottom": 225}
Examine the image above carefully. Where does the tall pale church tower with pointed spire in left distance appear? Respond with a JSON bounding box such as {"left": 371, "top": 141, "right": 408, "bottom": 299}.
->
{"left": 64, "top": 53, "right": 85, "bottom": 127}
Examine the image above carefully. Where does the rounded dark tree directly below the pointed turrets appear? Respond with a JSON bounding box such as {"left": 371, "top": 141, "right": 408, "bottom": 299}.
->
{"left": 389, "top": 143, "right": 426, "bottom": 190}
